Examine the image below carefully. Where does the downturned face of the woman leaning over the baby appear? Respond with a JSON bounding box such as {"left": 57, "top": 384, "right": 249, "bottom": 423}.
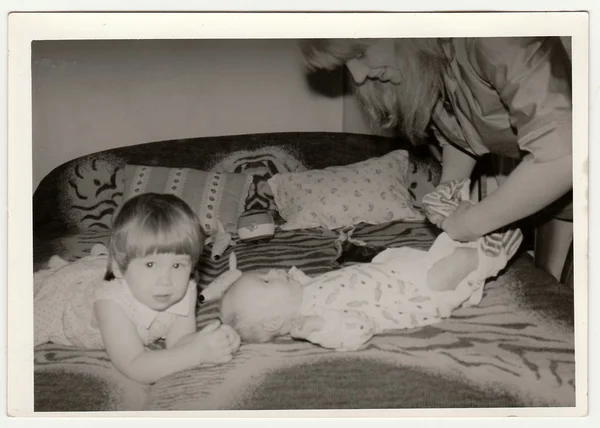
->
{"left": 346, "top": 39, "right": 401, "bottom": 85}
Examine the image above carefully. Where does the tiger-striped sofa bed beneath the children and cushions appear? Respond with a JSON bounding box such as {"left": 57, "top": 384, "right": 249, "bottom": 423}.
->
{"left": 33, "top": 132, "right": 575, "bottom": 412}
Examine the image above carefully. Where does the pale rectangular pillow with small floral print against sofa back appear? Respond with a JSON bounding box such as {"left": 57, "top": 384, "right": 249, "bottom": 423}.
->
{"left": 268, "top": 150, "right": 425, "bottom": 230}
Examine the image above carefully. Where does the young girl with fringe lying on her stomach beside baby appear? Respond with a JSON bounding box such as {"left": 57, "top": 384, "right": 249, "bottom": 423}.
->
{"left": 34, "top": 193, "right": 240, "bottom": 383}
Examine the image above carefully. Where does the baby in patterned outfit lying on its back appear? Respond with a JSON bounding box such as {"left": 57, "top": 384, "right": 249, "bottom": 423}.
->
{"left": 213, "top": 230, "right": 522, "bottom": 351}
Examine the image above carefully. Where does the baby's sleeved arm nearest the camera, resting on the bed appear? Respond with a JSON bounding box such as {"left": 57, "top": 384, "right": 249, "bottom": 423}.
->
{"left": 291, "top": 310, "right": 376, "bottom": 351}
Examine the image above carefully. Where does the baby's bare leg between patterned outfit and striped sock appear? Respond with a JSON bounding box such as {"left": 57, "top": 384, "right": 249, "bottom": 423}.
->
{"left": 427, "top": 248, "right": 479, "bottom": 291}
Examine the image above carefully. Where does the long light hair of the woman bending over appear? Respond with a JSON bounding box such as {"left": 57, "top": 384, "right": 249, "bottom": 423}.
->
{"left": 299, "top": 38, "right": 448, "bottom": 144}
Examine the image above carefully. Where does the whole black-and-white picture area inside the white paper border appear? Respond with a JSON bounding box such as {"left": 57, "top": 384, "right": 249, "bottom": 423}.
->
{"left": 10, "top": 10, "right": 586, "bottom": 413}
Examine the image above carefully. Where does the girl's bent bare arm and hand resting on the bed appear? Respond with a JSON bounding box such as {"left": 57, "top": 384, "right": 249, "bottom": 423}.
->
{"left": 94, "top": 300, "right": 238, "bottom": 384}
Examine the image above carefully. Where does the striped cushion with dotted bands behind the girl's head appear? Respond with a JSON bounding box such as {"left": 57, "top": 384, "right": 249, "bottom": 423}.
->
{"left": 123, "top": 165, "right": 252, "bottom": 233}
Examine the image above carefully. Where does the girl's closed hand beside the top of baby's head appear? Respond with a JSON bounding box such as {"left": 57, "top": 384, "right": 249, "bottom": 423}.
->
{"left": 190, "top": 321, "right": 240, "bottom": 363}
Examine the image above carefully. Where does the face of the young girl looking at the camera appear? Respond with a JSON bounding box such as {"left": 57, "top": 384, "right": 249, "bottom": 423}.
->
{"left": 120, "top": 253, "right": 192, "bottom": 311}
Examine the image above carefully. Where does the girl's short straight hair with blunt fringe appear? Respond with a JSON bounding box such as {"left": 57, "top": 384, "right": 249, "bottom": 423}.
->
{"left": 106, "top": 193, "right": 205, "bottom": 277}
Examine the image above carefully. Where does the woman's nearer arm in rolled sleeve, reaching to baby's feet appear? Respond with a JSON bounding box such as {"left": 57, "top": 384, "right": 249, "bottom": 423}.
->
{"left": 442, "top": 37, "right": 573, "bottom": 240}
